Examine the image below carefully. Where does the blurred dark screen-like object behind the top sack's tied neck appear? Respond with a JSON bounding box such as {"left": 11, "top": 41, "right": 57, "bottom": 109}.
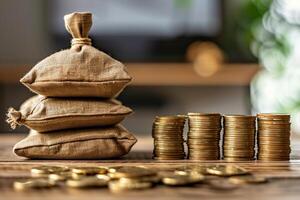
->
{"left": 47, "top": 0, "right": 224, "bottom": 62}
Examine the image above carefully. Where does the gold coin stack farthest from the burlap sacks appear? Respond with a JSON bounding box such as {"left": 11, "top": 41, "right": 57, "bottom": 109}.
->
{"left": 257, "top": 113, "right": 291, "bottom": 161}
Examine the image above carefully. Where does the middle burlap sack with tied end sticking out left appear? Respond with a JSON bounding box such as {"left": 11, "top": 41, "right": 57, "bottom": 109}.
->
{"left": 7, "top": 95, "right": 132, "bottom": 132}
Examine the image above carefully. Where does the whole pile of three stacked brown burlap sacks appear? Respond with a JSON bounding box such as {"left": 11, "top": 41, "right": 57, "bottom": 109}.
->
{"left": 7, "top": 13, "right": 137, "bottom": 159}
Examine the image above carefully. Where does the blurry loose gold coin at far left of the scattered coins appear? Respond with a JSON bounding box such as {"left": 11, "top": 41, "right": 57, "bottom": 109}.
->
{"left": 13, "top": 179, "right": 56, "bottom": 190}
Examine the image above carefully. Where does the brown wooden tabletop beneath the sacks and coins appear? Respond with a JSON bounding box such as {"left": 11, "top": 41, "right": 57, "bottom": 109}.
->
{"left": 0, "top": 134, "right": 300, "bottom": 200}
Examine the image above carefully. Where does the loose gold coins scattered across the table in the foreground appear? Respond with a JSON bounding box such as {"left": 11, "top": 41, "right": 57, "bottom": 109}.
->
{"left": 13, "top": 164, "right": 266, "bottom": 193}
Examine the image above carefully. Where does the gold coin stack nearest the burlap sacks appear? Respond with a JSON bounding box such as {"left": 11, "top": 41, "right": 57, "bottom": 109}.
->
{"left": 152, "top": 115, "right": 186, "bottom": 160}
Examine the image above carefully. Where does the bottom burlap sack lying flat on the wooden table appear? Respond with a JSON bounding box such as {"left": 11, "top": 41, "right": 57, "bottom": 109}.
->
{"left": 13, "top": 125, "right": 137, "bottom": 159}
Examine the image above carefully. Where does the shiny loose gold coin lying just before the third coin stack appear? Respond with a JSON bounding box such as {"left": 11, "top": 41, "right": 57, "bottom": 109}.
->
{"left": 207, "top": 165, "right": 249, "bottom": 176}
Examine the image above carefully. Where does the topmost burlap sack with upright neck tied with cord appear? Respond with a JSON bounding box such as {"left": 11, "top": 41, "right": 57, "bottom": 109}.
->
{"left": 20, "top": 13, "right": 131, "bottom": 98}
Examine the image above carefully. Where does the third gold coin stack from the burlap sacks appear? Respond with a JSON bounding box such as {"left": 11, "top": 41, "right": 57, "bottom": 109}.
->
{"left": 223, "top": 115, "right": 256, "bottom": 161}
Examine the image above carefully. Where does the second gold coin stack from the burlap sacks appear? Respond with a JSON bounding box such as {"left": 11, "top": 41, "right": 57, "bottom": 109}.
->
{"left": 187, "top": 113, "right": 222, "bottom": 160}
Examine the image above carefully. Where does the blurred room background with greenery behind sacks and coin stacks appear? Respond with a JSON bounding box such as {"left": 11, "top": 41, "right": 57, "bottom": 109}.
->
{"left": 0, "top": 0, "right": 300, "bottom": 135}
